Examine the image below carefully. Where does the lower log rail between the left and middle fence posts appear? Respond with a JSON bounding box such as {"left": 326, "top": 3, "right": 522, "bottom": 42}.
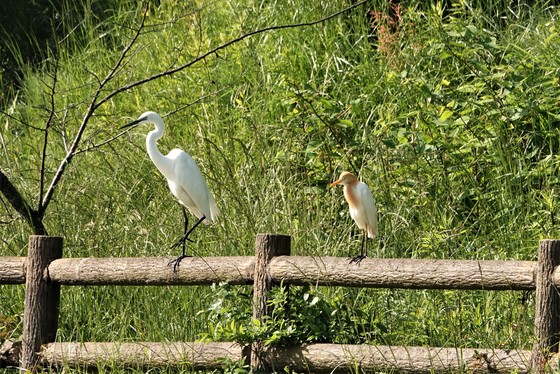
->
{"left": 41, "top": 342, "right": 248, "bottom": 370}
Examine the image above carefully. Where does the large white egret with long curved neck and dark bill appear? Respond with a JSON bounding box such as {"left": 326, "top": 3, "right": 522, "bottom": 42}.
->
{"left": 121, "top": 112, "right": 219, "bottom": 272}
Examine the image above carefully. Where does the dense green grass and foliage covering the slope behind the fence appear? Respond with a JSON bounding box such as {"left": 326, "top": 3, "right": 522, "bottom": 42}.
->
{"left": 0, "top": 0, "right": 560, "bottom": 372}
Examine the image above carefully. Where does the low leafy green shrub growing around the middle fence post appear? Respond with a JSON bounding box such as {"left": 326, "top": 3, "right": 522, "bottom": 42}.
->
{"left": 200, "top": 283, "right": 386, "bottom": 346}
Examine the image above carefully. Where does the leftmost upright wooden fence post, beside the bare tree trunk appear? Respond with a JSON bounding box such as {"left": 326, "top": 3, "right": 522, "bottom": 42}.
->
{"left": 21, "top": 235, "right": 62, "bottom": 372}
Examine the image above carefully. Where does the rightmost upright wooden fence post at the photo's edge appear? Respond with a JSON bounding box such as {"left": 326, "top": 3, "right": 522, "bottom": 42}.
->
{"left": 531, "top": 239, "right": 560, "bottom": 373}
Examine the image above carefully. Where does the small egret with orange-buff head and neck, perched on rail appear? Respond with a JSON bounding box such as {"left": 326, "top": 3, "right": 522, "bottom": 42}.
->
{"left": 329, "top": 171, "right": 377, "bottom": 263}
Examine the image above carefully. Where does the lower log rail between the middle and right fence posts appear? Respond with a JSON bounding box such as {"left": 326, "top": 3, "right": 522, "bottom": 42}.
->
{"left": 267, "top": 344, "right": 531, "bottom": 373}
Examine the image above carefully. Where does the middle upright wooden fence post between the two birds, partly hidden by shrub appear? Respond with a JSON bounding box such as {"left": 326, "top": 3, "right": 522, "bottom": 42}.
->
{"left": 251, "top": 234, "right": 291, "bottom": 372}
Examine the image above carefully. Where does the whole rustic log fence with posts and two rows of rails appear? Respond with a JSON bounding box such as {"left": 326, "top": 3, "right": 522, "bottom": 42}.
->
{"left": 0, "top": 234, "right": 560, "bottom": 373}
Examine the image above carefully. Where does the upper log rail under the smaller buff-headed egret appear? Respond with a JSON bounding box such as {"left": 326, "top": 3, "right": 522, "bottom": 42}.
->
{"left": 269, "top": 256, "right": 536, "bottom": 290}
